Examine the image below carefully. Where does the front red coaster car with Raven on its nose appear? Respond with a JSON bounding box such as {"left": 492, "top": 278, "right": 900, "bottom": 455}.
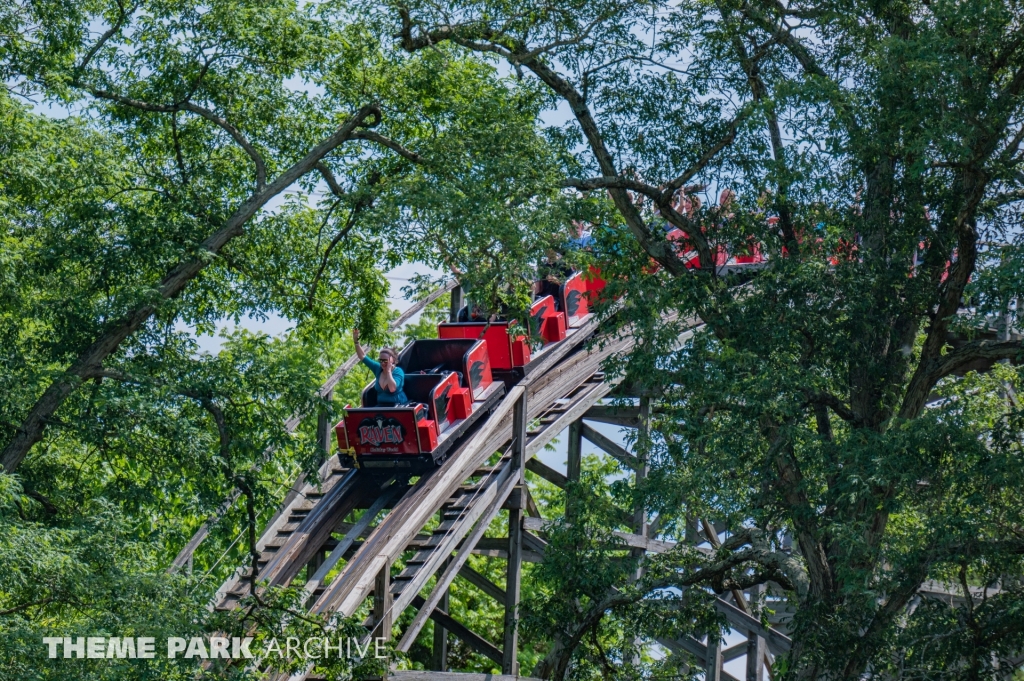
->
{"left": 334, "top": 338, "right": 505, "bottom": 468}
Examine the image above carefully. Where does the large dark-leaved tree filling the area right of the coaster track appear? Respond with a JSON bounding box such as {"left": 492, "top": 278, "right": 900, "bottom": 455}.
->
{"left": 387, "top": 0, "right": 1024, "bottom": 679}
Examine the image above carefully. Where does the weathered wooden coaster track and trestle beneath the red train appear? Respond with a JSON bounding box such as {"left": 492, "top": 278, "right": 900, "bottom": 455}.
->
{"left": 175, "top": 280, "right": 1019, "bottom": 681}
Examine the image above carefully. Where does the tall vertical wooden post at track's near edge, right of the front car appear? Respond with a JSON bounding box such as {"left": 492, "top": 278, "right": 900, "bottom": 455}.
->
{"left": 502, "top": 393, "right": 528, "bottom": 676}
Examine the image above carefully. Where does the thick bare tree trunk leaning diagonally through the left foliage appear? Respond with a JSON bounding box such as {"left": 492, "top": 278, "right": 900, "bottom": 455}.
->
{"left": 0, "top": 105, "right": 380, "bottom": 473}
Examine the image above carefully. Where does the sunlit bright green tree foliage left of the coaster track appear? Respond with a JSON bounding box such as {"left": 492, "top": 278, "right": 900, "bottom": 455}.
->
{"left": 0, "top": 0, "right": 571, "bottom": 679}
